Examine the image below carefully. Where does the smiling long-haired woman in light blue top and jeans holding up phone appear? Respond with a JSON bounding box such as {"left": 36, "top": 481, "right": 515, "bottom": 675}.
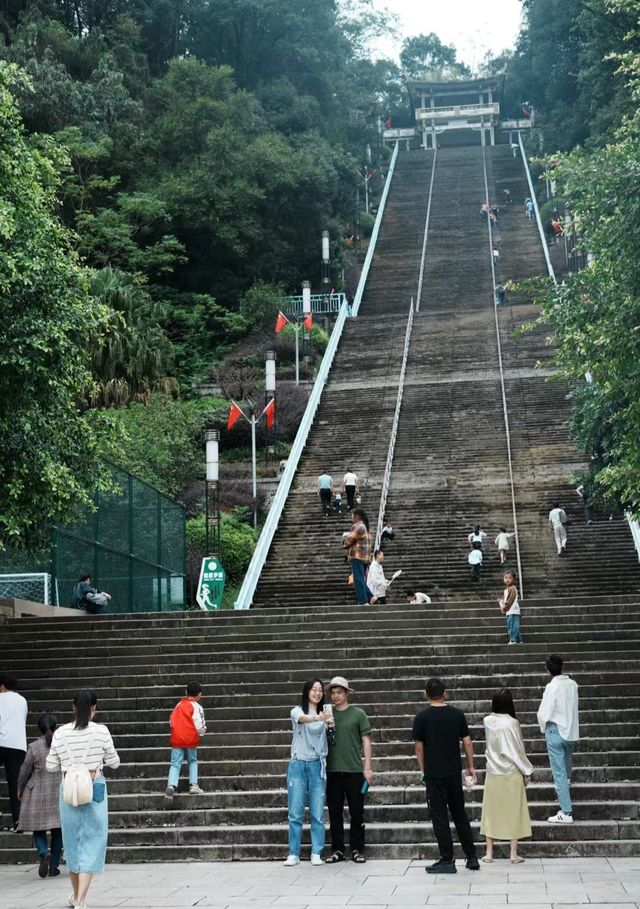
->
{"left": 284, "top": 676, "right": 333, "bottom": 867}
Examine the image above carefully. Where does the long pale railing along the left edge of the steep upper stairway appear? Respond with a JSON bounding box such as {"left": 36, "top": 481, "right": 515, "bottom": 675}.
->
{"left": 234, "top": 144, "right": 398, "bottom": 609}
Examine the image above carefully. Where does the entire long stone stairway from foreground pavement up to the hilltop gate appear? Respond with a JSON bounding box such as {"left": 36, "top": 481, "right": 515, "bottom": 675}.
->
{"left": 0, "top": 147, "right": 640, "bottom": 862}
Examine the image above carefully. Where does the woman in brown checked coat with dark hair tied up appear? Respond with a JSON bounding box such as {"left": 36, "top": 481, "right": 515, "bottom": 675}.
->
{"left": 18, "top": 713, "right": 62, "bottom": 877}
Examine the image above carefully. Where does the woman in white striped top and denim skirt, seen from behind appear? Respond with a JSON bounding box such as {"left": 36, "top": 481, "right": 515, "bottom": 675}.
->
{"left": 47, "top": 691, "right": 120, "bottom": 909}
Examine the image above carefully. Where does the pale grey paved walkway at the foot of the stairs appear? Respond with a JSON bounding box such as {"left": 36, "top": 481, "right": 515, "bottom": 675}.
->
{"left": 5, "top": 858, "right": 640, "bottom": 909}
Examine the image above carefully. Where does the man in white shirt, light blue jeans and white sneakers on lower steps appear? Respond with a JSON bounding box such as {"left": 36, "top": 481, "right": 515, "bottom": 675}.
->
{"left": 538, "top": 653, "right": 580, "bottom": 824}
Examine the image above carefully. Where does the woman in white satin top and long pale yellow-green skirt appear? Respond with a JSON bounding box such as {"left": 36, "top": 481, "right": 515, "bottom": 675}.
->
{"left": 480, "top": 688, "right": 533, "bottom": 864}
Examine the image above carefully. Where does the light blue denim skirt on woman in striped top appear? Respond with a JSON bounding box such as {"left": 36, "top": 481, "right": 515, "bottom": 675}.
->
{"left": 60, "top": 786, "right": 109, "bottom": 874}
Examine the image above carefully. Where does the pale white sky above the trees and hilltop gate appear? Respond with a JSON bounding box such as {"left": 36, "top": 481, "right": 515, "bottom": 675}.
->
{"left": 373, "top": 0, "right": 524, "bottom": 70}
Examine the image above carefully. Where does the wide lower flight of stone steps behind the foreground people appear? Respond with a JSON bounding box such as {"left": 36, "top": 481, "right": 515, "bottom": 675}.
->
{"left": 0, "top": 597, "right": 640, "bottom": 863}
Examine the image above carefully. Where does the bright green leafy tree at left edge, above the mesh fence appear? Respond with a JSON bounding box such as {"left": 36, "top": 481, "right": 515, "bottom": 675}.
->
{"left": 0, "top": 62, "right": 107, "bottom": 547}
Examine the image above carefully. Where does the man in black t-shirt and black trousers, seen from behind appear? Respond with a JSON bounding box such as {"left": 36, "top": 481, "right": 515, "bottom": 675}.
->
{"left": 413, "top": 678, "right": 480, "bottom": 874}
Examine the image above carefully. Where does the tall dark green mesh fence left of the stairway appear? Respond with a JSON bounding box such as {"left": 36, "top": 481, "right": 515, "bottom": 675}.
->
{"left": 52, "top": 466, "right": 185, "bottom": 612}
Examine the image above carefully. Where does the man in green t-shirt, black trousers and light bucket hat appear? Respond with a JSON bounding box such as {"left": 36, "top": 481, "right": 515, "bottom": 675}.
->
{"left": 326, "top": 675, "right": 373, "bottom": 865}
